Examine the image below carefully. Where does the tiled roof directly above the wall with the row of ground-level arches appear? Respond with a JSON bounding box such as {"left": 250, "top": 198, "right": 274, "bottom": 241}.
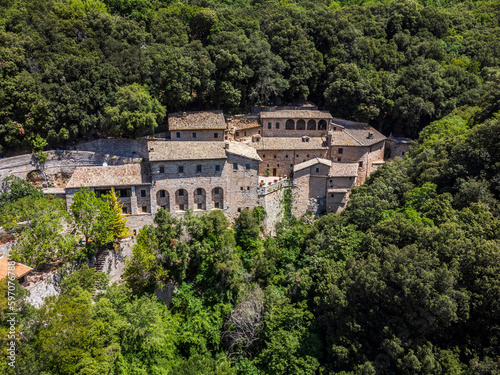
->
{"left": 148, "top": 141, "right": 227, "bottom": 161}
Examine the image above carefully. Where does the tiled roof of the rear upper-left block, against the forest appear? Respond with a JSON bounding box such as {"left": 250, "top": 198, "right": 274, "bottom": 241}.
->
{"left": 168, "top": 111, "right": 226, "bottom": 131}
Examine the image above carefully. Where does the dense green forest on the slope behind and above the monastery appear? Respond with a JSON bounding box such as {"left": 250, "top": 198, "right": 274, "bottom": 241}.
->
{"left": 0, "top": 0, "right": 500, "bottom": 152}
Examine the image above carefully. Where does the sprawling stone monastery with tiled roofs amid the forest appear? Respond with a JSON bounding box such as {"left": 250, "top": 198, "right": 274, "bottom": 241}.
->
{"left": 65, "top": 107, "right": 386, "bottom": 234}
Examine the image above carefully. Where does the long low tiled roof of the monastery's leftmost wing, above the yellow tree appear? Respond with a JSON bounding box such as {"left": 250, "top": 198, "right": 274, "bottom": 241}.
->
{"left": 66, "top": 163, "right": 150, "bottom": 188}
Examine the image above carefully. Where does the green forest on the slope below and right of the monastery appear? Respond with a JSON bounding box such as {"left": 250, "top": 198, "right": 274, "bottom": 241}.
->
{"left": 0, "top": 90, "right": 500, "bottom": 375}
